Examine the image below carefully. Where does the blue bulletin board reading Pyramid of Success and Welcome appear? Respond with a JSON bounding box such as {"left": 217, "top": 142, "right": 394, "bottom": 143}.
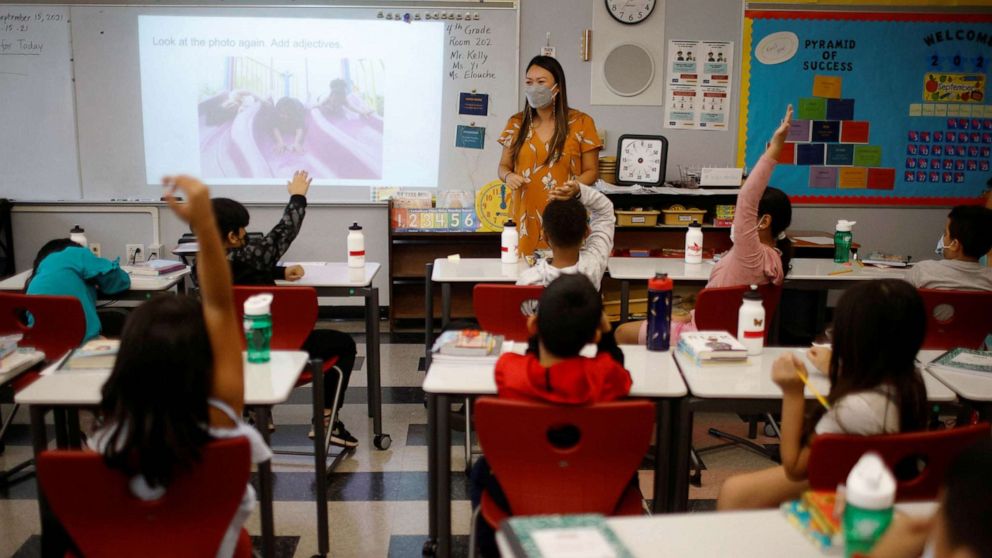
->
{"left": 737, "top": 9, "right": 992, "bottom": 205}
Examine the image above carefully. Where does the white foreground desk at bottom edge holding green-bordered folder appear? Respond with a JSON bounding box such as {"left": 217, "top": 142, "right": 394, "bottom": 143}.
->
{"left": 496, "top": 502, "right": 937, "bottom": 558}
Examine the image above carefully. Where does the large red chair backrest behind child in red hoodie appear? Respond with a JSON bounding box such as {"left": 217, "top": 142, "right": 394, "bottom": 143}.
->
{"left": 475, "top": 397, "right": 654, "bottom": 515}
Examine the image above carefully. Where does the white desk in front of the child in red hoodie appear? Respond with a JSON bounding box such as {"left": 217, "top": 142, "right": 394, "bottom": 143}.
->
{"left": 423, "top": 343, "right": 688, "bottom": 558}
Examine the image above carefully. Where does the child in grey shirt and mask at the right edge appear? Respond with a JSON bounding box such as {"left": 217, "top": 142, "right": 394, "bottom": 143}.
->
{"left": 906, "top": 205, "right": 992, "bottom": 291}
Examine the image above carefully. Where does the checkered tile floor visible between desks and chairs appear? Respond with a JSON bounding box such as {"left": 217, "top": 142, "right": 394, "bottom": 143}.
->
{"left": 0, "top": 322, "right": 770, "bottom": 558}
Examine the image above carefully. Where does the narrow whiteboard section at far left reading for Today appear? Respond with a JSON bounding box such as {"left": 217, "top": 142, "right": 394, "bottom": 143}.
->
{"left": 0, "top": 6, "right": 80, "bottom": 200}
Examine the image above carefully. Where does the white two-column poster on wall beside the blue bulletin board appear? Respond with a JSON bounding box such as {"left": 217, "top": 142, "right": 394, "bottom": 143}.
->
{"left": 665, "top": 41, "right": 734, "bottom": 131}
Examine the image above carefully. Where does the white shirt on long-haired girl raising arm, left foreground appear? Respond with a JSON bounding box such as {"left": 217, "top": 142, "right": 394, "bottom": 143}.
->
{"left": 86, "top": 399, "right": 272, "bottom": 558}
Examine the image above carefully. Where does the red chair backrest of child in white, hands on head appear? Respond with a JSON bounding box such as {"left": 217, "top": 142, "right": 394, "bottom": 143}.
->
{"left": 472, "top": 283, "right": 544, "bottom": 341}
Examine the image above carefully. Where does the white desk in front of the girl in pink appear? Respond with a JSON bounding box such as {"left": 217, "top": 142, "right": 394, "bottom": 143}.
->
{"left": 607, "top": 258, "right": 905, "bottom": 323}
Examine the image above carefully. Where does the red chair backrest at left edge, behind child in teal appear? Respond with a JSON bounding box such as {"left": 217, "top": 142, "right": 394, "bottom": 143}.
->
{"left": 0, "top": 292, "right": 86, "bottom": 359}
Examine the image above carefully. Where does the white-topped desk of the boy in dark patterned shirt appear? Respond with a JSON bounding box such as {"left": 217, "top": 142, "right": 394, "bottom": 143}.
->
{"left": 276, "top": 262, "right": 392, "bottom": 450}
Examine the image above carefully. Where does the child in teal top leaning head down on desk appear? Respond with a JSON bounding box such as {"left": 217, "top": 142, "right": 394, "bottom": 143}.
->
{"left": 24, "top": 238, "right": 131, "bottom": 342}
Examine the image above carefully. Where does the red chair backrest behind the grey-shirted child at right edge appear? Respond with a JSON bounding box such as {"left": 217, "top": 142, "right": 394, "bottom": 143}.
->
{"left": 919, "top": 289, "right": 992, "bottom": 349}
